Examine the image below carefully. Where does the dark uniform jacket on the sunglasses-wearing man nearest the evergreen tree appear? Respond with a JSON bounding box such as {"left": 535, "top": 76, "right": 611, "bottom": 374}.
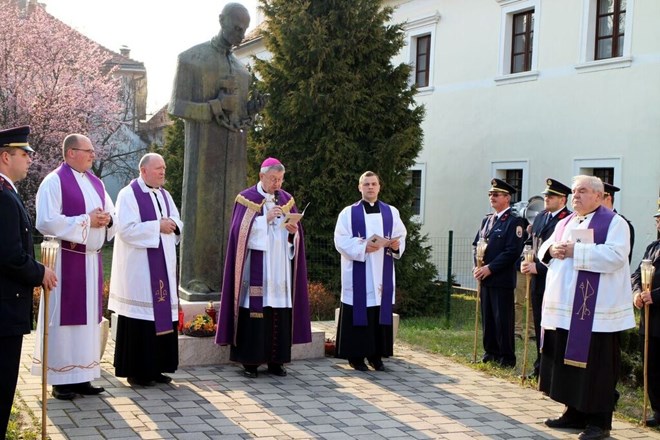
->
{"left": 472, "top": 208, "right": 525, "bottom": 289}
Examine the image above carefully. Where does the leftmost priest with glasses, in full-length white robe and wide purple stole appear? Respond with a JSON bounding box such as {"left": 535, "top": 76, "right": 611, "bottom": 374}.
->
{"left": 32, "top": 134, "right": 117, "bottom": 400}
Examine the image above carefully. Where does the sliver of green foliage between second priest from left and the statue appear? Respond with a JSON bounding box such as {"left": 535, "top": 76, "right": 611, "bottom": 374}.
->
{"left": 152, "top": 116, "right": 185, "bottom": 209}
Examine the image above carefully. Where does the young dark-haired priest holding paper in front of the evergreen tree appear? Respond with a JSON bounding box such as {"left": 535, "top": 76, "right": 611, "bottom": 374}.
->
{"left": 335, "top": 171, "right": 407, "bottom": 371}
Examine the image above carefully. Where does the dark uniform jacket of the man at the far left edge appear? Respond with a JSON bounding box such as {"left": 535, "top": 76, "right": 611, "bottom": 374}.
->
{"left": 0, "top": 176, "right": 44, "bottom": 336}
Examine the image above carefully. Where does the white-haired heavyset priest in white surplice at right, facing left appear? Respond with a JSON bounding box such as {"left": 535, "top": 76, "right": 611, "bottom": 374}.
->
{"left": 538, "top": 176, "right": 635, "bottom": 439}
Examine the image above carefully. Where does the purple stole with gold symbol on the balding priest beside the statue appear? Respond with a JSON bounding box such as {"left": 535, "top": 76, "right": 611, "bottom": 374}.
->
{"left": 131, "top": 179, "right": 173, "bottom": 335}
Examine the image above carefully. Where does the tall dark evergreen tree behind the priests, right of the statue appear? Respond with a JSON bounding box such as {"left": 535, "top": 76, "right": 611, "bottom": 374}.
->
{"left": 252, "top": 0, "right": 436, "bottom": 313}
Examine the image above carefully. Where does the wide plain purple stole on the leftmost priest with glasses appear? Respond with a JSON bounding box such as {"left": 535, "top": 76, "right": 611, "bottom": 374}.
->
{"left": 55, "top": 163, "right": 105, "bottom": 325}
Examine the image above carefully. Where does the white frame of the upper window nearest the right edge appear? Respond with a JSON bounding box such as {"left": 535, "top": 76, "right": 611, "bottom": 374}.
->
{"left": 575, "top": 0, "right": 635, "bottom": 73}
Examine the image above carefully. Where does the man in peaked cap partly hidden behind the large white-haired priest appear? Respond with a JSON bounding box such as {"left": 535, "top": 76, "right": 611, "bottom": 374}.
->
{"left": 520, "top": 178, "right": 571, "bottom": 376}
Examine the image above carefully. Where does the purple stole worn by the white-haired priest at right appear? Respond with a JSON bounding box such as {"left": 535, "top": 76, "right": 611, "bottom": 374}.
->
{"left": 556, "top": 206, "right": 616, "bottom": 368}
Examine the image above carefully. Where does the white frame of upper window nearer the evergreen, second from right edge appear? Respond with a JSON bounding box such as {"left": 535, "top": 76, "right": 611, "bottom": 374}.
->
{"left": 495, "top": 0, "right": 541, "bottom": 85}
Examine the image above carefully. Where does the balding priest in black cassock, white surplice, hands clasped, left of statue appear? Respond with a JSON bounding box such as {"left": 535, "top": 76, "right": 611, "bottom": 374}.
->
{"left": 108, "top": 153, "right": 183, "bottom": 386}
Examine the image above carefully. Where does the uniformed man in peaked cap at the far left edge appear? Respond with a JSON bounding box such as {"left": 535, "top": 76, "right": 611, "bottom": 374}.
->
{"left": 0, "top": 126, "right": 57, "bottom": 438}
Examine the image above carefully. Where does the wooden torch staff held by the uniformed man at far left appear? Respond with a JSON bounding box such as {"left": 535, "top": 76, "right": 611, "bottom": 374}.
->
{"left": 41, "top": 235, "right": 59, "bottom": 440}
